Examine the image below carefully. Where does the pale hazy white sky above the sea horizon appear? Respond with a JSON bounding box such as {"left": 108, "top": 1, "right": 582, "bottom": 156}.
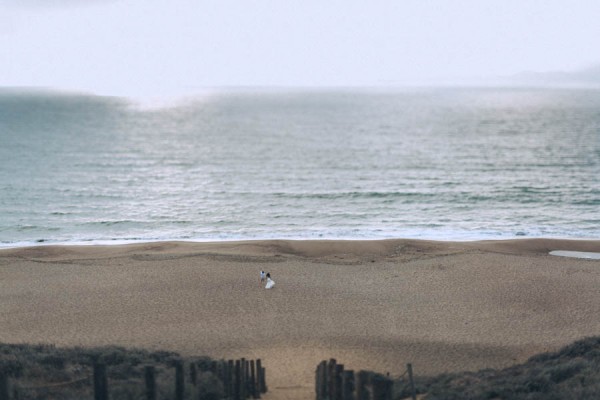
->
{"left": 0, "top": 0, "right": 600, "bottom": 95}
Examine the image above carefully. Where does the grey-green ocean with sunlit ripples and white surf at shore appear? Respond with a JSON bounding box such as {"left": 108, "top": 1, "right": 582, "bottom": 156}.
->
{"left": 0, "top": 88, "right": 600, "bottom": 247}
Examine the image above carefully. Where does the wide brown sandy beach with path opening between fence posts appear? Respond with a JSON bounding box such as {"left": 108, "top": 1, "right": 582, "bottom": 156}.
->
{"left": 0, "top": 239, "right": 600, "bottom": 399}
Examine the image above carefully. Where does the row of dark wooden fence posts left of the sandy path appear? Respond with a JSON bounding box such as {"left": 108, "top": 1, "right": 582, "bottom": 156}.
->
{"left": 0, "top": 358, "right": 267, "bottom": 400}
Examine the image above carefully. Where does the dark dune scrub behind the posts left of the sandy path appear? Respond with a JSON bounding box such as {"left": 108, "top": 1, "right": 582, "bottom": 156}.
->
{"left": 0, "top": 343, "right": 223, "bottom": 400}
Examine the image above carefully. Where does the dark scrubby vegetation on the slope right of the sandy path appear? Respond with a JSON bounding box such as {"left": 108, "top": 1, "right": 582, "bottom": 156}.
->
{"left": 394, "top": 336, "right": 600, "bottom": 400}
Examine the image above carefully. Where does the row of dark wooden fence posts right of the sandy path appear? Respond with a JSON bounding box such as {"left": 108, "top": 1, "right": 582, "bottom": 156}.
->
{"left": 315, "top": 358, "right": 416, "bottom": 400}
